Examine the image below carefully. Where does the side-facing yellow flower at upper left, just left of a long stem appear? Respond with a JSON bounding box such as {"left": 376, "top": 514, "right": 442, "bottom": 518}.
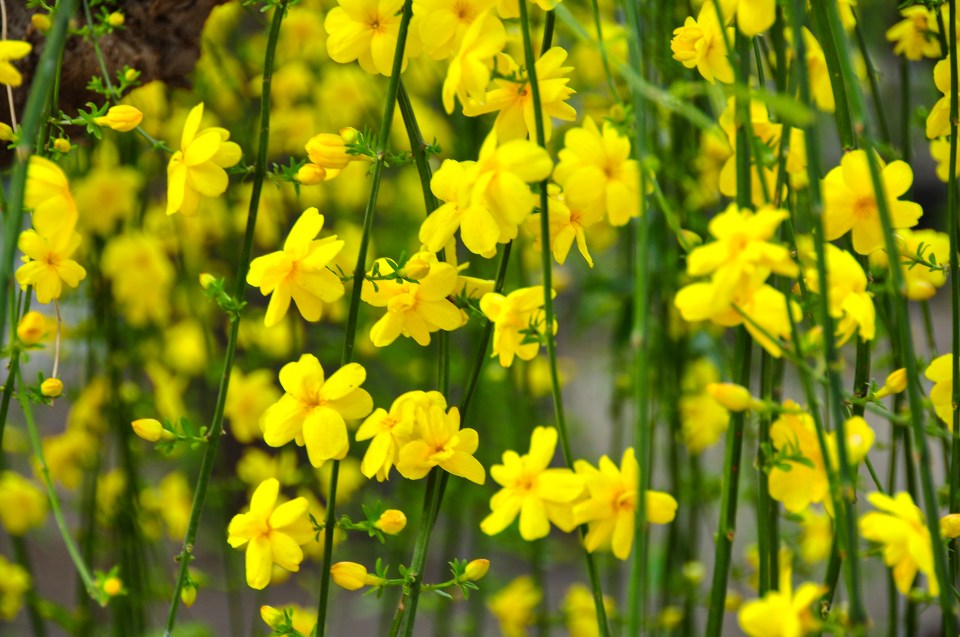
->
{"left": 167, "top": 102, "right": 241, "bottom": 216}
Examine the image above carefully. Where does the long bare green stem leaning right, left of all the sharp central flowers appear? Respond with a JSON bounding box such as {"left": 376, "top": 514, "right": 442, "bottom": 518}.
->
{"left": 164, "top": 0, "right": 287, "bottom": 637}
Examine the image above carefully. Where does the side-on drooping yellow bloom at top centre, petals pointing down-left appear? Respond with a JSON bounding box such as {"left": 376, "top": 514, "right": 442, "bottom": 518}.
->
{"left": 440, "top": 10, "right": 507, "bottom": 113}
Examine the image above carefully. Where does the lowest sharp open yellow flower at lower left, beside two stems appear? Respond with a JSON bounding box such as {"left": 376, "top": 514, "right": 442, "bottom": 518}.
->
{"left": 227, "top": 478, "right": 307, "bottom": 590}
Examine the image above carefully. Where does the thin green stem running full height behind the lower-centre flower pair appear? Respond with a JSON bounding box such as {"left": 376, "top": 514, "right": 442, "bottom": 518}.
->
{"left": 519, "top": 1, "right": 608, "bottom": 637}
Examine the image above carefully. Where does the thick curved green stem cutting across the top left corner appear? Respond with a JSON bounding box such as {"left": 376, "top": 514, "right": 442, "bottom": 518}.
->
{"left": 0, "top": 0, "right": 77, "bottom": 360}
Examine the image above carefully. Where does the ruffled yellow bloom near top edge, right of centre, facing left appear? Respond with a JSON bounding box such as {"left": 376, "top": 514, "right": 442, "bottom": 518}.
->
{"left": 670, "top": 0, "right": 734, "bottom": 84}
